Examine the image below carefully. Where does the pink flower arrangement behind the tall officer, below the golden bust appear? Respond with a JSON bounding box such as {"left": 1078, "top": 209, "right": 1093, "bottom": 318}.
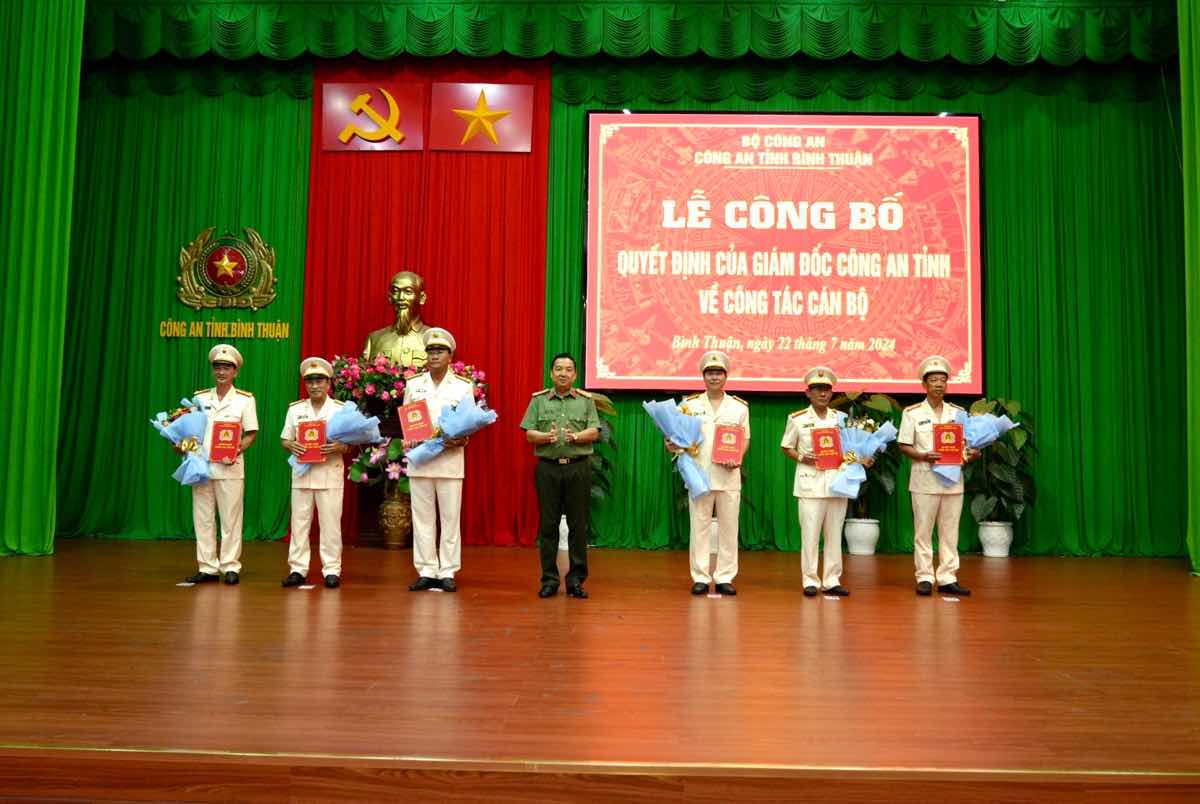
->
{"left": 332, "top": 354, "right": 487, "bottom": 496}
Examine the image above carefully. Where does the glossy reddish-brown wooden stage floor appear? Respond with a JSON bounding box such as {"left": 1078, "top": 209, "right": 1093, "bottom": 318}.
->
{"left": 0, "top": 540, "right": 1200, "bottom": 802}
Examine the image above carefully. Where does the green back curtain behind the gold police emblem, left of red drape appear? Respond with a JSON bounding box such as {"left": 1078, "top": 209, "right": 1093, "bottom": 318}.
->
{"left": 59, "top": 64, "right": 312, "bottom": 539}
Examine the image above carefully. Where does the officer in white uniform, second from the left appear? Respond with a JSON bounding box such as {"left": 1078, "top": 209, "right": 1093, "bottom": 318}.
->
{"left": 280, "top": 358, "right": 349, "bottom": 589}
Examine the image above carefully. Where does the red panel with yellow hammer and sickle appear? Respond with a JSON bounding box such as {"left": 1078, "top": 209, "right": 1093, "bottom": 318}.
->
{"left": 320, "top": 82, "right": 425, "bottom": 151}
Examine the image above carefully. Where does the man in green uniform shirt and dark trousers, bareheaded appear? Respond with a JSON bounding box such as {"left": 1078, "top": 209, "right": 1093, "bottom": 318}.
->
{"left": 521, "top": 353, "right": 600, "bottom": 598}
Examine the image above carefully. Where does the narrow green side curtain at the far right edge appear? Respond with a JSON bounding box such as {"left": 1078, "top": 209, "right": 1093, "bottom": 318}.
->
{"left": 1180, "top": 0, "right": 1200, "bottom": 575}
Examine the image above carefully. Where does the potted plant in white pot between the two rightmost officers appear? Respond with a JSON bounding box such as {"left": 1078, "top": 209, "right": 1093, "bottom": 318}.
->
{"left": 829, "top": 391, "right": 900, "bottom": 556}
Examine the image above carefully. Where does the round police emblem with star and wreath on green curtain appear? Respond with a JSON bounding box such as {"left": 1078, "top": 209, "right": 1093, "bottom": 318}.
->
{"left": 178, "top": 226, "right": 275, "bottom": 310}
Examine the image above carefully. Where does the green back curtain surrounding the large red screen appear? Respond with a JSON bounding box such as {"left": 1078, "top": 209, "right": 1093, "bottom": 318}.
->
{"left": 546, "top": 60, "right": 1188, "bottom": 556}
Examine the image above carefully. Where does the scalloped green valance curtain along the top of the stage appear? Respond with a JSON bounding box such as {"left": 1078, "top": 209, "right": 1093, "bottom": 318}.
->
{"left": 85, "top": 0, "right": 1177, "bottom": 65}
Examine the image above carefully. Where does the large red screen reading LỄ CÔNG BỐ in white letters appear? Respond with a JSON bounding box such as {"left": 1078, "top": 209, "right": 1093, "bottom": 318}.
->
{"left": 584, "top": 114, "right": 983, "bottom": 394}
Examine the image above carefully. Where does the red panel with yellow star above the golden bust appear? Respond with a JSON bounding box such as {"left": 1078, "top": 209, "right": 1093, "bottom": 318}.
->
{"left": 430, "top": 83, "right": 533, "bottom": 152}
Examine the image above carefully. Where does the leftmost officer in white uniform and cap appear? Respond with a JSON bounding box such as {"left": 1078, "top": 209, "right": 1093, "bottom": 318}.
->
{"left": 186, "top": 343, "right": 258, "bottom": 584}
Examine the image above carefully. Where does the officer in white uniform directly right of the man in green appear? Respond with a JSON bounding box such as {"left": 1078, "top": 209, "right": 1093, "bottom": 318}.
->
{"left": 666, "top": 352, "right": 750, "bottom": 595}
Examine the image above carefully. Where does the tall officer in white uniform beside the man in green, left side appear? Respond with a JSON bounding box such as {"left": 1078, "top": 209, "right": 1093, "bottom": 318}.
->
{"left": 404, "top": 326, "right": 475, "bottom": 592}
